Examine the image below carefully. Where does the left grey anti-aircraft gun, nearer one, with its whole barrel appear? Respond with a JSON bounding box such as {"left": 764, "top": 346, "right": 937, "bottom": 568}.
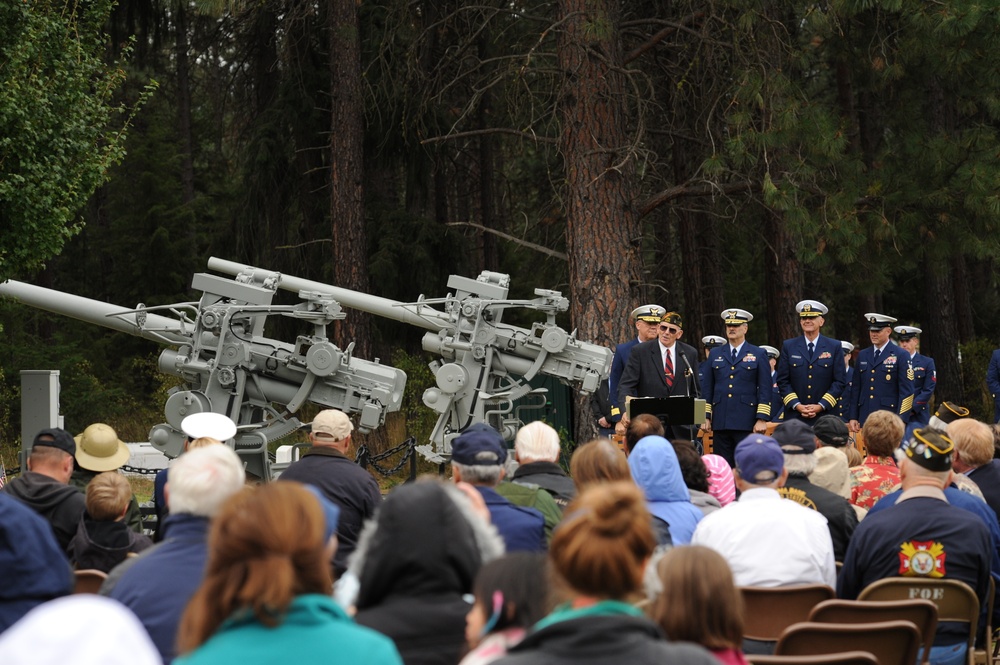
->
{"left": 0, "top": 271, "right": 406, "bottom": 479}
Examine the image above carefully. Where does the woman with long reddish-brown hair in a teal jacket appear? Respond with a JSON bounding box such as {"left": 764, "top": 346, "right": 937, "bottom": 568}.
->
{"left": 174, "top": 482, "right": 401, "bottom": 665}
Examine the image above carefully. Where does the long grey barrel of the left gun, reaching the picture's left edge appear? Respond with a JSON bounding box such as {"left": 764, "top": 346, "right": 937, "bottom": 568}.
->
{"left": 0, "top": 280, "right": 190, "bottom": 344}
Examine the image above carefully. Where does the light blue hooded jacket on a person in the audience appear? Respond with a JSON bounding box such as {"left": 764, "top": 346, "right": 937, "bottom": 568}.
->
{"left": 628, "top": 436, "right": 703, "bottom": 545}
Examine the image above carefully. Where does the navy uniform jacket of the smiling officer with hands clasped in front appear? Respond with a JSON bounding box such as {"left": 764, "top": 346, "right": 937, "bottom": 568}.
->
{"left": 778, "top": 335, "right": 847, "bottom": 420}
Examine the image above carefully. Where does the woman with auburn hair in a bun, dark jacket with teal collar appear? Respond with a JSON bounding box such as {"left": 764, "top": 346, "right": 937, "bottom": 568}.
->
{"left": 495, "top": 482, "right": 718, "bottom": 665}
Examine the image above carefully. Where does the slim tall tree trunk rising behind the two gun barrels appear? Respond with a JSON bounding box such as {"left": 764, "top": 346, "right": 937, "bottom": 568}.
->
{"left": 328, "top": 0, "right": 372, "bottom": 358}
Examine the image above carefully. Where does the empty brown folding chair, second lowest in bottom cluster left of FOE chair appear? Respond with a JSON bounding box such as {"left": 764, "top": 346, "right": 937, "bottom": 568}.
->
{"left": 774, "top": 621, "right": 920, "bottom": 665}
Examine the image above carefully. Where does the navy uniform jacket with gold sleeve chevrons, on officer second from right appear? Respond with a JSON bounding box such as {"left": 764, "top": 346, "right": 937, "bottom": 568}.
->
{"left": 848, "top": 341, "right": 913, "bottom": 425}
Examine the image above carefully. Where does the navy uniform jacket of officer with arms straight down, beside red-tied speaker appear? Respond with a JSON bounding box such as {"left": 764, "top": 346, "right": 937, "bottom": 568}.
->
{"left": 702, "top": 342, "right": 772, "bottom": 432}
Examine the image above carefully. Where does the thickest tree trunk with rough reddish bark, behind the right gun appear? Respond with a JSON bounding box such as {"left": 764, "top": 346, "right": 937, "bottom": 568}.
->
{"left": 558, "top": 0, "right": 641, "bottom": 442}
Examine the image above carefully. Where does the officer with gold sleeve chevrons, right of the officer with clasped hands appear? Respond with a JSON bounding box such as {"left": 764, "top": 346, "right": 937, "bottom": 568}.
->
{"left": 848, "top": 312, "right": 913, "bottom": 433}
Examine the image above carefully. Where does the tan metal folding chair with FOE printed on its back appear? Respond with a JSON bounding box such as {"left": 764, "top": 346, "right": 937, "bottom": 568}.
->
{"left": 858, "top": 577, "right": 990, "bottom": 665}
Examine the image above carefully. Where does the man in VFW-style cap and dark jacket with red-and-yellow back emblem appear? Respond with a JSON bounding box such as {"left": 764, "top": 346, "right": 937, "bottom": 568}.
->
{"left": 837, "top": 429, "right": 993, "bottom": 665}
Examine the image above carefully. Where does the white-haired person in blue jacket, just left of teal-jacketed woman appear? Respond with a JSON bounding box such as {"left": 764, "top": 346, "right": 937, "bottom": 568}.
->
{"left": 101, "top": 446, "right": 245, "bottom": 663}
